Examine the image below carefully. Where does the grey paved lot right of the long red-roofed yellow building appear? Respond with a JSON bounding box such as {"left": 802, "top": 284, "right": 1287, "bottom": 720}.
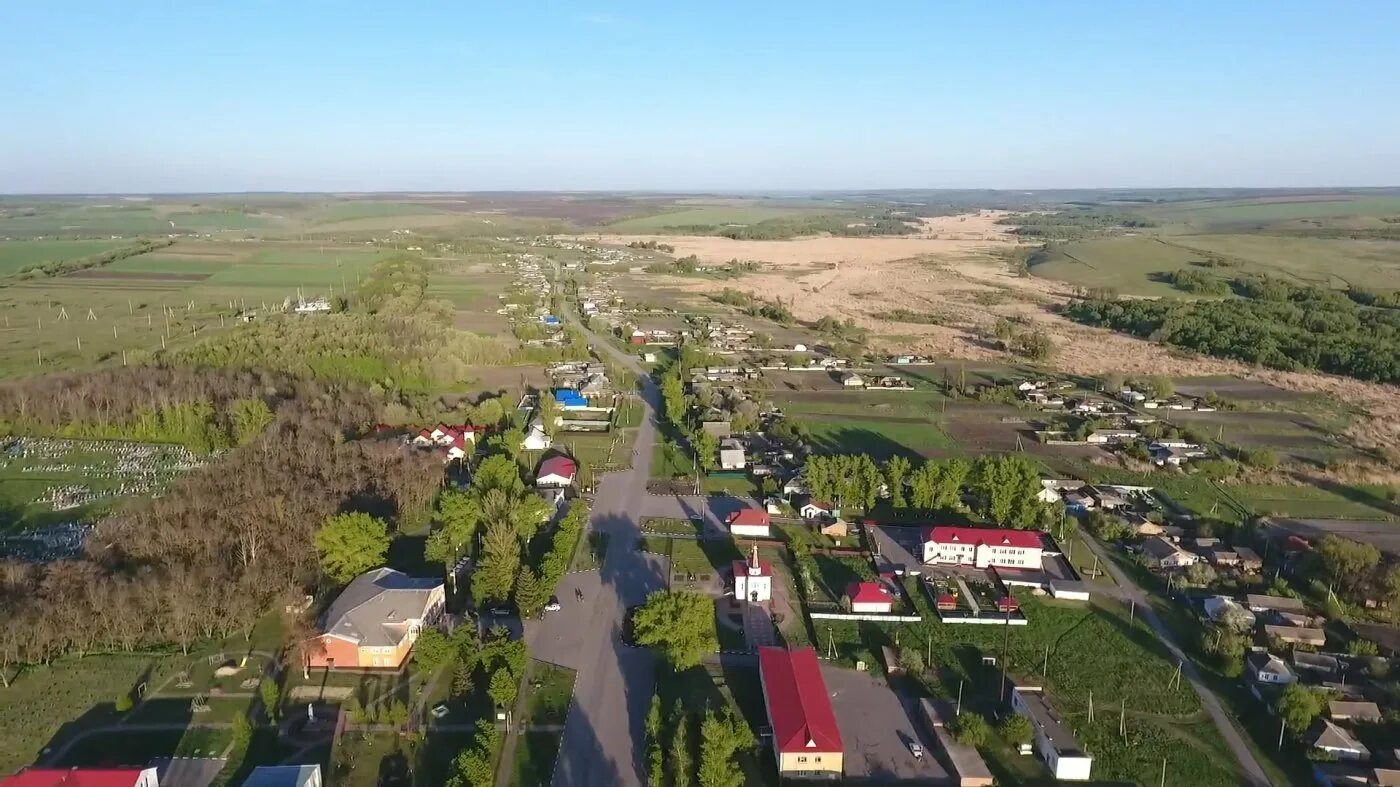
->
{"left": 822, "top": 664, "right": 949, "bottom": 786}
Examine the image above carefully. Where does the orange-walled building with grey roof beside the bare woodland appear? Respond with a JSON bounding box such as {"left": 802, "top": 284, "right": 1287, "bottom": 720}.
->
{"left": 307, "top": 569, "right": 447, "bottom": 669}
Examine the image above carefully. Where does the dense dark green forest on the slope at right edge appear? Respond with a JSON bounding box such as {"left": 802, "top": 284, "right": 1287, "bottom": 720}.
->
{"left": 1064, "top": 274, "right": 1400, "bottom": 382}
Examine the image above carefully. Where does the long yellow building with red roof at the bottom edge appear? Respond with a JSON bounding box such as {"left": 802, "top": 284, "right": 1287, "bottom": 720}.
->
{"left": 759, "top": 647, "right": 846, "bottom": 781}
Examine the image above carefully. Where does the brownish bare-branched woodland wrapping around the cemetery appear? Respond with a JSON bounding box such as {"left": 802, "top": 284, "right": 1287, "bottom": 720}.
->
{"left": 0, "top": 370, "right": 441, "bottom": 675}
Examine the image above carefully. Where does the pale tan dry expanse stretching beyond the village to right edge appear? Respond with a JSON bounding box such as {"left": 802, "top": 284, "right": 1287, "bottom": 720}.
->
{"left": 589, "top": 211, "right": 1400, "bottom": 464}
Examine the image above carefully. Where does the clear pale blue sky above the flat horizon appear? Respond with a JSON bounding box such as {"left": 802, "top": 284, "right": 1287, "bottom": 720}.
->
{"left": 0, "top": 0, "right": 1400, "bottom": 193}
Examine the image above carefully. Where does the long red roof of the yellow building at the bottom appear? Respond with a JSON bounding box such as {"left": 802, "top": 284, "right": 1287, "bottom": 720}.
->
{"left": 759, "top": 647, "right": 843, "bottom": 753}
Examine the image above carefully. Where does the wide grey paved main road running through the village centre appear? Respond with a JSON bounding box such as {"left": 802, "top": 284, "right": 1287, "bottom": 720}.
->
{"left": 553, "top": 303, "right": 666, "bottom": 787}
